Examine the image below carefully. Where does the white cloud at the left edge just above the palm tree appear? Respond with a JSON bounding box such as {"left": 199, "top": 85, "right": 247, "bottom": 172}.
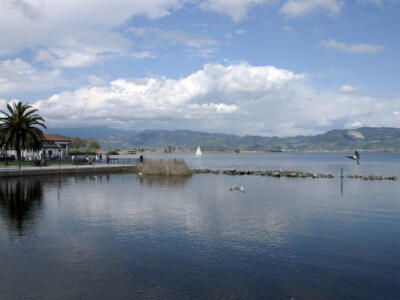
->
{"left": 0, "top": 58, "right": 68, "bottom": 95}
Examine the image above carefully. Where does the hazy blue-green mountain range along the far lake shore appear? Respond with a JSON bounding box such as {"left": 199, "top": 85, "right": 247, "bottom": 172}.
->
{"left": 47, "top": 127, "right": 400, "bottom": 151}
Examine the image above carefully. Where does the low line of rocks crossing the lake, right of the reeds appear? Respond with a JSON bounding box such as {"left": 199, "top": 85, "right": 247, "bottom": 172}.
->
{"left": 194, "top": 169, "right": 397, "bottom": 181}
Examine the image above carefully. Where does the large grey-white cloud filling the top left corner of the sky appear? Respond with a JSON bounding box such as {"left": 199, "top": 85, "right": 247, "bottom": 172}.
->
{"left": 0, "top": 0, "right": 185, "bottom": 67}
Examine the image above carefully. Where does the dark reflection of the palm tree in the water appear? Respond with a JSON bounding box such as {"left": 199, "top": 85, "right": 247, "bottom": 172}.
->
{"left": 0, "top": 179, "right": 43, "bottom": 236}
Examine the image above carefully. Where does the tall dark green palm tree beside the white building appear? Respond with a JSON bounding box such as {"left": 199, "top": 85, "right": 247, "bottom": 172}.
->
{"left": 0, "top": 102, "right": 47, "bottom": 167}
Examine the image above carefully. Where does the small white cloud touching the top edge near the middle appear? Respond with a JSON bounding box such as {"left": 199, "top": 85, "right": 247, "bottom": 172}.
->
{"left": 200, "top": 0, "right": 279, "bottom": 22}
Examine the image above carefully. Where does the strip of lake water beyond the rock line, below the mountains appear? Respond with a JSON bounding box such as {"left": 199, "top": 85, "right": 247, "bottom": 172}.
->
{"left": 126, "top": 152, "right": 400, "bottom": 177}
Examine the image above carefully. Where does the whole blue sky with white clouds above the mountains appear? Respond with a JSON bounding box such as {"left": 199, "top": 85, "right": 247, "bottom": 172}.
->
{"left": 0, "top": 0, "right": 400, "bottom": 136}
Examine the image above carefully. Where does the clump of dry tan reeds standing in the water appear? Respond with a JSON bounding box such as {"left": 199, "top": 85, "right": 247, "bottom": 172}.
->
{"left": 137, "top": 159, "right": 193, "bottom": 176}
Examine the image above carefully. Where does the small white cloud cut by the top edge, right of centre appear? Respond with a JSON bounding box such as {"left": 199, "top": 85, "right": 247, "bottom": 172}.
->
{"left": 280, "top": 0, "right": 344, "bottom": 18}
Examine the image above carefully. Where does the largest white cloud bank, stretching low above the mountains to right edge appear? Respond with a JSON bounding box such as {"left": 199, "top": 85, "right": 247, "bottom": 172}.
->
{"left": 9, "top": 62, "right": 394, "bottom": 136}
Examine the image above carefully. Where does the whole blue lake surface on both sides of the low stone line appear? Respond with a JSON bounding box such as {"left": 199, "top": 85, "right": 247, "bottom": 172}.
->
{"left": 0, "top": 153, "right": 400, "bottom": 299}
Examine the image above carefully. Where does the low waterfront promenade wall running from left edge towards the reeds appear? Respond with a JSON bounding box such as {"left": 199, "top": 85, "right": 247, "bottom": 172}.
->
{"left": 0, "top": 164, "right": 136, "bottom": 177}
